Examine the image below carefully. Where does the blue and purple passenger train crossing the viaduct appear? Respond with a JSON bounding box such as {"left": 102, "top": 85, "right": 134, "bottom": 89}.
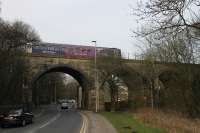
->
{"left": 28, "top": 43, "right": 121, "bottom": 58}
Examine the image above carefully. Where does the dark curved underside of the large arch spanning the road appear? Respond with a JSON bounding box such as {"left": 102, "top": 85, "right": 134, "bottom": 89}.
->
{"left": 31, "top": 65, "right": 89, "bottom": 109}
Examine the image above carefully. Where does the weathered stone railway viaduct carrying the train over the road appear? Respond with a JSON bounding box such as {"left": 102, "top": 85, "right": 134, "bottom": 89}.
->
{"left": 27, "top": 55, "right": 199, "bottom": 110}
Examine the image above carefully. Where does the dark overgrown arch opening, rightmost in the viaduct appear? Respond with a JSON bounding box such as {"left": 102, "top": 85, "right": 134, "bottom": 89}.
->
{"left": 158, "top": 70, "right": 182, "bottom": 110}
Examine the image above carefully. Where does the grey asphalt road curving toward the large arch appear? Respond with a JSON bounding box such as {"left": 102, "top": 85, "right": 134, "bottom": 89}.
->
{"left": 0, "top": 105, "right": 83, "bottom": 133}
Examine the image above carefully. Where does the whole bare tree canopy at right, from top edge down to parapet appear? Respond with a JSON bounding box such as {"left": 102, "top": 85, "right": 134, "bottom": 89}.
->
{"left": 133, "top": 0, "right": 200, "bottom": 63}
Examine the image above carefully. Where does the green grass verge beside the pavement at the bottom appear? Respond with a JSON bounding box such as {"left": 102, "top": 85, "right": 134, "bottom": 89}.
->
{"left": 100, "top": 112, "right": 164, "bottom": 133}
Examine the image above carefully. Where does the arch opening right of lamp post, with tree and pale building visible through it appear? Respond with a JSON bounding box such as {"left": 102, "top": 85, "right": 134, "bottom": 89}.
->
{"left": 100, "top": 75, "right": 128, "bottom": 111}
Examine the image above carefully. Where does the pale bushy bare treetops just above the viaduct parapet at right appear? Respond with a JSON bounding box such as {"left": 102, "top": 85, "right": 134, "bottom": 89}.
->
{"left": 143, "top": 33, "right": 200, "bottom": 63}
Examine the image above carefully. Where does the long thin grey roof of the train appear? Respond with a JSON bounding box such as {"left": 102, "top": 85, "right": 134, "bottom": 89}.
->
{"left": 35, "top": 42, "right": 120, "bottom": 50}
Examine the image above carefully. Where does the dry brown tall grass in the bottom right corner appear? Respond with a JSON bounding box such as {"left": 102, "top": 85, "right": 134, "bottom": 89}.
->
{"left": 134, "top": 108, "right": 200, "bottom": 133}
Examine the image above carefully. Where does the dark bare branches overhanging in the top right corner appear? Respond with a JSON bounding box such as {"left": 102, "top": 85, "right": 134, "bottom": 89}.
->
{"left": 134, "top": 0, "right": 200, "bottom": 36}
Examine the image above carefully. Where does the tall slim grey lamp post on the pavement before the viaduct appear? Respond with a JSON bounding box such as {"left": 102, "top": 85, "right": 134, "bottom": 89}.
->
{"left": 92, "top": 41, "right": 99, "bottom": 112}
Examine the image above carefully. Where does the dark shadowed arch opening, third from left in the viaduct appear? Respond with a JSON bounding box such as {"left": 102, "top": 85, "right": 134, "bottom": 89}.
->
{"left": 114, "top": 66, "right": 149, "bottom": 110}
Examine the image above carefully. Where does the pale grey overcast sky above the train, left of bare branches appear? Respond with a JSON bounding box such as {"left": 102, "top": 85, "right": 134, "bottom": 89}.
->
{"left": 1, "top": 0, "right": 140, "bottom": 57}
